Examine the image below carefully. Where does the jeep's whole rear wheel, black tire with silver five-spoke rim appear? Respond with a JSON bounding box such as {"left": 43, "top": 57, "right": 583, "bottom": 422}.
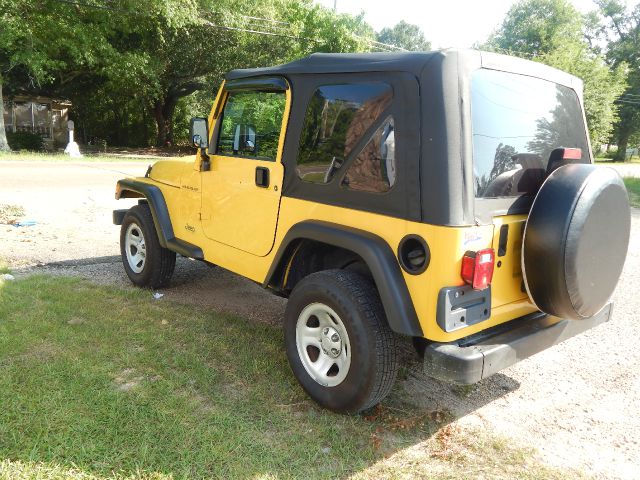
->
{"left": 284, "top": 270, "right": 398, "bottom": 413}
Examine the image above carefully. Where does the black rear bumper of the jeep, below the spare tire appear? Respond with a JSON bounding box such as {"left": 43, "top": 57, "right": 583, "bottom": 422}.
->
{"left": 424, "top": 303, "right": 613, "bottom": 385}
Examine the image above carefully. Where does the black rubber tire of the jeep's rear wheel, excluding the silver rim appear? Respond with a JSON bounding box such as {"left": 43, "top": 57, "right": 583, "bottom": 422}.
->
{"left": 284, "top": 270, "right": 399, "bottom": 413}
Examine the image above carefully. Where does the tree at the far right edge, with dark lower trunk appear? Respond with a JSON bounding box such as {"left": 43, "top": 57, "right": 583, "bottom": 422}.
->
{"left": 595, "top": 0, "right": 640, "bottom": 161}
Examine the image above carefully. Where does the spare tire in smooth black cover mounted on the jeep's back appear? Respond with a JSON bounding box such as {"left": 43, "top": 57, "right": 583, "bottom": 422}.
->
{"left": 522, "top": 164, "right": 631, "bottom": 320}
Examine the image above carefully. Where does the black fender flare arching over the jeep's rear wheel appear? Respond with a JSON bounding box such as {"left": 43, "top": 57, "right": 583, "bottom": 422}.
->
{"left": 263, "top": 221, "right": 422, "bottom": 337}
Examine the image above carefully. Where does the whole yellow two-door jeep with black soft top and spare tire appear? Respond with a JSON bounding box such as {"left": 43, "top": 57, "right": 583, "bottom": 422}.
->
{"left": 114, "top": 51, "right": 630, "bottom": 412}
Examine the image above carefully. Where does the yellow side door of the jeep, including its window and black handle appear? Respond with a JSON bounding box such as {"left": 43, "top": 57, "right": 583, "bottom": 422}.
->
{"left": 201, "top": 86, "right": 289, "bottom": 256}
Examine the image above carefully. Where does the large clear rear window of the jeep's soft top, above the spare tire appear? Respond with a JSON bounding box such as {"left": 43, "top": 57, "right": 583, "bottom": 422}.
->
{"left": 471, "top": 69, "right": 589, "bottom": 198}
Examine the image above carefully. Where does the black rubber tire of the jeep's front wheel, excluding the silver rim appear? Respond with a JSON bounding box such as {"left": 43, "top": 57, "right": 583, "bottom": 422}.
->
{"left": 120, "top": 205, "right": 176, "bottom": 288}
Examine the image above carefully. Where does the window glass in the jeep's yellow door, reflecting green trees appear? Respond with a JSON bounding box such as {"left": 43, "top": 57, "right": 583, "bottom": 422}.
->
{"left": 216, "top": 92, "right": 286, "bottom": 160}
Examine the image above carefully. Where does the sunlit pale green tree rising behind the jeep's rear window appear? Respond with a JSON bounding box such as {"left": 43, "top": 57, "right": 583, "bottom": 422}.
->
{"left": 483, "top": 0, "right": 627, "bottom": 145}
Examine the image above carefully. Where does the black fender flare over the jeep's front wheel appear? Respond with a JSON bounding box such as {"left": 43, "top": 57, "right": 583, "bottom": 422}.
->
{"left": 116, "top": 179, "right": 204, "bottom": 260}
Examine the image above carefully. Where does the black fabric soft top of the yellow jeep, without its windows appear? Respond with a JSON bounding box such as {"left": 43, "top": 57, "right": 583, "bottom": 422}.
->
{"left": 226, "top": 49, "right": 582, "bottom": 225}
